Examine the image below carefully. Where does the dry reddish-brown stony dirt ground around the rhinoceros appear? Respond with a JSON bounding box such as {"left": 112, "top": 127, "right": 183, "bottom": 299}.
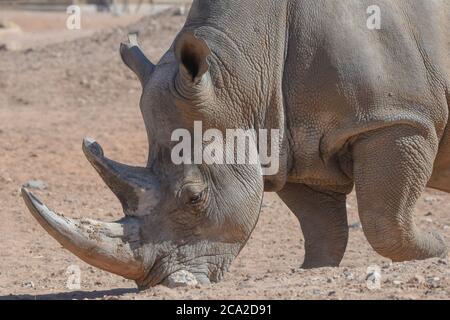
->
{"left": 0, "top": 11, "right": 450, "bottom": 299}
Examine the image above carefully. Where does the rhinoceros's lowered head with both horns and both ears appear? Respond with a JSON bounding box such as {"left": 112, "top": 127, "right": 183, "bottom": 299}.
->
{"left": 22, "top": 32, "right": 264, "bottom": 288}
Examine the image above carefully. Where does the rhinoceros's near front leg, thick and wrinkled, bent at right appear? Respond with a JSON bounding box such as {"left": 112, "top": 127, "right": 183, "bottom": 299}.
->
{"left": 353, "top": 126, "right": 447, "bottom": 261}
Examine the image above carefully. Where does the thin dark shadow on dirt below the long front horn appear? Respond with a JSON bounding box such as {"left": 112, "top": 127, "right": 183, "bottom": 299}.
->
{"left": 0, "top": 288, "right": 139, "bottom": 300}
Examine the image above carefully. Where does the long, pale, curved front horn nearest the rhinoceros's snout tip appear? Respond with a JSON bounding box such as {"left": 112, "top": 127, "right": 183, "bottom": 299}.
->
{"left": 22, "top": 188, "right": 144, "bottom": 280}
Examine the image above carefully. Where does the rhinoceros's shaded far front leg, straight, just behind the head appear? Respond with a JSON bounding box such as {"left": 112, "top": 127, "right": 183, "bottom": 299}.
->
{"left": 278, "top": 184, "right": 348, "bottom": 268}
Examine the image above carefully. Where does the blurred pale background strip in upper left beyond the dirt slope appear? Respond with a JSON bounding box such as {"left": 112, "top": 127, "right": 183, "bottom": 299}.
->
{"left": 0, "top": 0, "right": 190, "bottom": 50}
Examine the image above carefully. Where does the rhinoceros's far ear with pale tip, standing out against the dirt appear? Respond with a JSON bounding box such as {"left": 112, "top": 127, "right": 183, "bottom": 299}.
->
{"left": 120, "top": 33, "right": 155, "bottom": 86}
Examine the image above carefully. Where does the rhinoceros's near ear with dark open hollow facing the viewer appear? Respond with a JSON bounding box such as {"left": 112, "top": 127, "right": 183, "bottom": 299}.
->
{"left": 175, "top": 32, "right": 211, "bottom": 83}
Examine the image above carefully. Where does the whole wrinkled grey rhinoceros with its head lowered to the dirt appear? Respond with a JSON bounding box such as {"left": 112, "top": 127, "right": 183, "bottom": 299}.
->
{"left": 23, "top": 0, "right": 450, "bottom": 288}
